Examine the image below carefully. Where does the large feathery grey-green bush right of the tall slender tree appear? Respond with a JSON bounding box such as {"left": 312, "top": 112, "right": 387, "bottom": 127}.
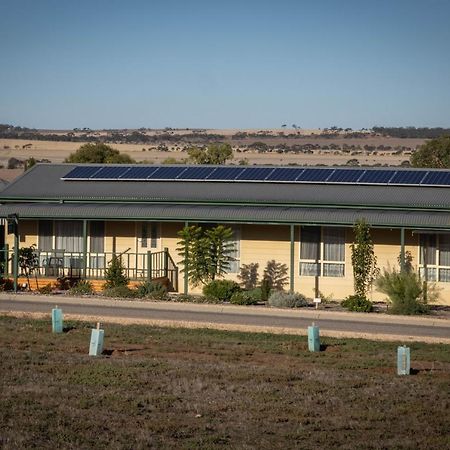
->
{"left": 376, "top": 269, "right": 438, "bottom": 315}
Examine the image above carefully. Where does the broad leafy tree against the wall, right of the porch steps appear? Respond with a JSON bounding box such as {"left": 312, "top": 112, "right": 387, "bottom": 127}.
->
{"left": 177, "top": 225, "right": 234, "bottom": 286}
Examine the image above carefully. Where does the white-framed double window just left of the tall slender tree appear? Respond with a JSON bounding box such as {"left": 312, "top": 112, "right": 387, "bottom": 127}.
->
{"left": 300, "top": 227, "right": 345, "bottom": 277}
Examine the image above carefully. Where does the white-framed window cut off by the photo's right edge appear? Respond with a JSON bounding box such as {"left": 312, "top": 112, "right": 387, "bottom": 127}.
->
{"left": 419, "top": 234, "right": 450, "bottom": 283}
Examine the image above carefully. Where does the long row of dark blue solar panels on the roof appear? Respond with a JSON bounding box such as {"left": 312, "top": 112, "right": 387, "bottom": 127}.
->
{"left": 62, "top": 165, "right": 450, "bottom": 186}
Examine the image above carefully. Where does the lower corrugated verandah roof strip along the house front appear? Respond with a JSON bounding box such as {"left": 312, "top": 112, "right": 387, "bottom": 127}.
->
{"left": 0, "top": 203, "right": 450, "bottom": 229}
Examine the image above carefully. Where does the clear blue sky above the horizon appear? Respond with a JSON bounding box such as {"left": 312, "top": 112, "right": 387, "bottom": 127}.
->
{"left": 0, "top": 0, "right": 450, "bottom": 129}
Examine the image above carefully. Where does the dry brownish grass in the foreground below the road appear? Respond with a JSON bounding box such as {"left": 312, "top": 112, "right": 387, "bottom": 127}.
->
{"left": 0, "top": 316, "right": 450, "bottom": 450}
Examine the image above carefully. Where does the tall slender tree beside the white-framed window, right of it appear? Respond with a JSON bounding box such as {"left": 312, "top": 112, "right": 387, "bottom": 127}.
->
{"left": 350, "top": 219, "right": 379, "bottom": 300}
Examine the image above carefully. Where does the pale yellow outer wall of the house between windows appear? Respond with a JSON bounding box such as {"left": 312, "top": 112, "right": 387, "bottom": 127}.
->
{"left": 6, "top": 221, "right": 450, "bottom": 305}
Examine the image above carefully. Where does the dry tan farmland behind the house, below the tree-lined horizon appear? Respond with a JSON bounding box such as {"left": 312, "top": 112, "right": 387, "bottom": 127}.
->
{"left": 0, "top": 136, "right": 424, "bottom": 167}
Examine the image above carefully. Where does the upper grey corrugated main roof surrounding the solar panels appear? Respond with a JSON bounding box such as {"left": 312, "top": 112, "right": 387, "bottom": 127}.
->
{"left": 0, "top": 164, "right": 450, "bottom": 209}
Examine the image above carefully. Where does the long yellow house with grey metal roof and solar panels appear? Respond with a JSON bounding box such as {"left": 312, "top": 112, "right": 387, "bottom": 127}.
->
{"left": 0, "top": 164, "right": 450, "bottom": 305}
